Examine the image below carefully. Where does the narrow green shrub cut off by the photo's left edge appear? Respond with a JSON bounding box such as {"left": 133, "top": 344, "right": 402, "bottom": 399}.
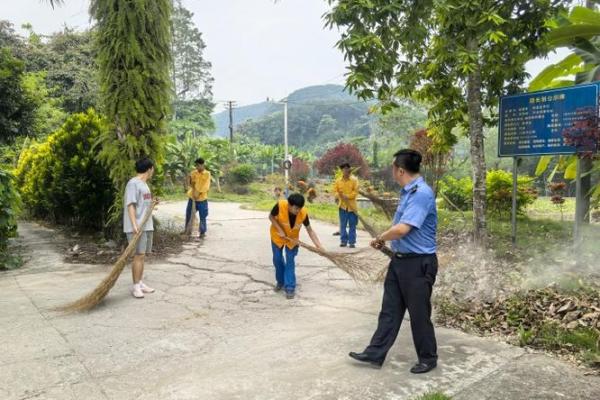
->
{"left": 0, "top": 169, "right": 20, "bottom": 262}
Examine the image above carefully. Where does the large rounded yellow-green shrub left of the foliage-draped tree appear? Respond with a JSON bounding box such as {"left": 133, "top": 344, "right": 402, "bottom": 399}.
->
{"left": 16, "top": 109, "right": 114, "bottom": 229}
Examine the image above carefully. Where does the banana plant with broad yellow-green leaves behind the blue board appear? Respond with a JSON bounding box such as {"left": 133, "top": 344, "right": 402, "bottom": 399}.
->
{"left": 529, "top": 3, "right": 600, "bottom": 200}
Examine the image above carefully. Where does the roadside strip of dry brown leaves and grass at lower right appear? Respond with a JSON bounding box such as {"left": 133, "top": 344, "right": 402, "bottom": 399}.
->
{"left": 436, "top": 287, "right": 600, "bottom": 374}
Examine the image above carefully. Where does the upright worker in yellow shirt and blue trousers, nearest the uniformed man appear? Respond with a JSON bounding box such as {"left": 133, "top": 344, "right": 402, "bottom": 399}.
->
{"left": 333, "top": 163, "right": 358, "bottom": 248}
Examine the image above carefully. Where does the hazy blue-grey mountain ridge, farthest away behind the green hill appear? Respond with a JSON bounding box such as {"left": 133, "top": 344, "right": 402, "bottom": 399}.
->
{"left": 213, "top": 85, "right": 366, "bottom": 137}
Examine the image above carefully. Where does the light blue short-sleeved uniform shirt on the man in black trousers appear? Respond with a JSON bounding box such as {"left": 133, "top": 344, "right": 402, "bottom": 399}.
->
{"left": 392, "top": 177, "right": 437, "bottom": 254}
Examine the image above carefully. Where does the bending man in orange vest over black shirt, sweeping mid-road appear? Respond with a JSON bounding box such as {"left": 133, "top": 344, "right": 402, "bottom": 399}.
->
{"left": 269, "top": 193, "right": 323, "bottom": 299}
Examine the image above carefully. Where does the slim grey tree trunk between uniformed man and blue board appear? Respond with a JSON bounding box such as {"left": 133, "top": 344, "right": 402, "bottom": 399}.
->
{"left": 467, "top": 41, "right": 487, "bottom": 248}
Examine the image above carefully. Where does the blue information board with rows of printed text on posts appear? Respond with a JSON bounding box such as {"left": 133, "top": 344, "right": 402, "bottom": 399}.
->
{"left": 498, "top": 84, "right": 598, "bottom": 157}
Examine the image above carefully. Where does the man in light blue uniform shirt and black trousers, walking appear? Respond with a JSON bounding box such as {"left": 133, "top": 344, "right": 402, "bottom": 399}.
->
{"left": 350, "top": 150, "right": 437, "bottom": 374}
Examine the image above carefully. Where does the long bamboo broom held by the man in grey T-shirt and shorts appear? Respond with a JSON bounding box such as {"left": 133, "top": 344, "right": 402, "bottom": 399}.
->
{"left": 55, "top": 200, "right": 158, "bottom": 312}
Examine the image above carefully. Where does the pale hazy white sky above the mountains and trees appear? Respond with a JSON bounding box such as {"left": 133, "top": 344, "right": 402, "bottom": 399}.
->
{"left": 0, "top": 0, "right": 566, "bottom": 111}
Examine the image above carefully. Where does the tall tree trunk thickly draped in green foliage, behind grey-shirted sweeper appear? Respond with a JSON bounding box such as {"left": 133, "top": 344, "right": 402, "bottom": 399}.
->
{"left": 90, "top": 0, "right": 172, "bottom": 222}
